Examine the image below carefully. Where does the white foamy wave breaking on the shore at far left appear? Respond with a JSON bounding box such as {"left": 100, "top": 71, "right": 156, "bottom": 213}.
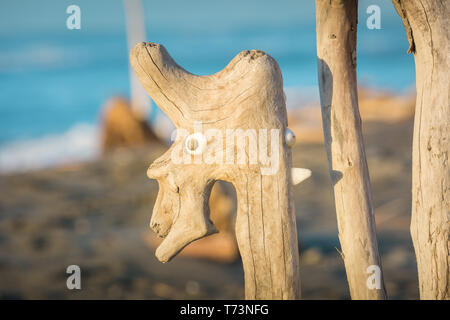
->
{"left": 0, "top": 123, "right": 100, "bottom": 173}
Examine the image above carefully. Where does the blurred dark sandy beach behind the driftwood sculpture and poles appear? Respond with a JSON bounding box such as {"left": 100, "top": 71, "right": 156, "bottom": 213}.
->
{"left": 0, "top": 93, "right": 418, "bottom": 299}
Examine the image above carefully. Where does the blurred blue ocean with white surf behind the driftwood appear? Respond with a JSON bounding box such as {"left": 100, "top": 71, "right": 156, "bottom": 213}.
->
{"left": 0, "top": 0, "right": 414, "bottom": 172}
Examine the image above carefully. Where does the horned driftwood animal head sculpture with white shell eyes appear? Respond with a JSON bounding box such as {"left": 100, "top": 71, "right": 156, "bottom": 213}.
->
{"left": 130, "top": 43, "right": 310, "bottom": 299}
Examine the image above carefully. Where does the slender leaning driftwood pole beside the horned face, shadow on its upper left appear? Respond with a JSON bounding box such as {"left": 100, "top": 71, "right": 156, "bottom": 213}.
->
{"left": 316, "top": 0, "right": 386, "bottom": 299}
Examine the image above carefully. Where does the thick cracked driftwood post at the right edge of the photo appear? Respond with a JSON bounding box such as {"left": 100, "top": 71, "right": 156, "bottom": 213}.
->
{"left": 393, "top": 0, "right": 450, "bottom": 299}
